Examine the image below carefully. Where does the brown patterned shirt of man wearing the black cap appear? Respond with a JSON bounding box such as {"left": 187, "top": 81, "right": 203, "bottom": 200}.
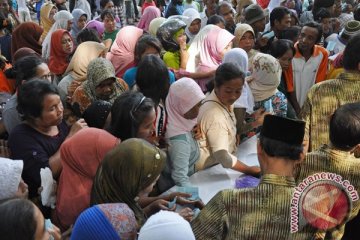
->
{"left": 191, "top": 174, "right": 312, "bottom": 240}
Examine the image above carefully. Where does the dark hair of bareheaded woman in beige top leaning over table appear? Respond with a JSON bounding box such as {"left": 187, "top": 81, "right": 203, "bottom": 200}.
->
{"left": 215, "top": 62, "right": 245, "bottom": 87}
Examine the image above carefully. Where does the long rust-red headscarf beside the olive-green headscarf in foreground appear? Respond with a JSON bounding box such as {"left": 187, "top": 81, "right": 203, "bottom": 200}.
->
{"left": 56, "top": 128, "right": 118, "bottom": 226}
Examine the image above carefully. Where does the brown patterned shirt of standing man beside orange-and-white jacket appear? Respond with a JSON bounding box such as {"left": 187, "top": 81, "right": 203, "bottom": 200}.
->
{"left": 301, "top": 72, "right": 360, "bottom": 151}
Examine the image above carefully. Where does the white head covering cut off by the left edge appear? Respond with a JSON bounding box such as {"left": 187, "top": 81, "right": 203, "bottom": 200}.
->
{"left": 0, "top": 158, "right": 24, "bottom": 200}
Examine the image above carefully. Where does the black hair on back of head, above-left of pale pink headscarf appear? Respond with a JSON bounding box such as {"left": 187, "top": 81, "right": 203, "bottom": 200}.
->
{"left": 136, "top": 55, "right": 170, "bottom": 105}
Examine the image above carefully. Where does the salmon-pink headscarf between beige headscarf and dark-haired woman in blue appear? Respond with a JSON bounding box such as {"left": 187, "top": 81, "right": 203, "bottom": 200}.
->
{"left": 106, "top": 26, "right": 144, "bottom": 77}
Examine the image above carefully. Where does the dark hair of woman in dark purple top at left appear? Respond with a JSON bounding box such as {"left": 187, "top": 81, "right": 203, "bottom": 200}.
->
{"left": 17, "top": 79, "right": 59, "bottom": 120}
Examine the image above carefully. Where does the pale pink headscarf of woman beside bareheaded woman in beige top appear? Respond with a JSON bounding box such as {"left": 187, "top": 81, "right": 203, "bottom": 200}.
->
{"left": 165, "top": 78, "right": 205, "bottom": 138}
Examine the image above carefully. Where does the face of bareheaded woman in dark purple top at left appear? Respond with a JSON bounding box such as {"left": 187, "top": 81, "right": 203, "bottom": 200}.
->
{"left": 37, "top": 94, "right": 64, "bottom": 127}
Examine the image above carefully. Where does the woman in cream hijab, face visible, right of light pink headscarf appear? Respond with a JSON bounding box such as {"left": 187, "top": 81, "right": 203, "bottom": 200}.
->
{"left": 233, "top": 23, "right": 258, "bottom": 65}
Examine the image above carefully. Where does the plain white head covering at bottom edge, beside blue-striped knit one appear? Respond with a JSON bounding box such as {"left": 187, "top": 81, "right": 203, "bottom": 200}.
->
{"left": 138, "top": 210, "right": 195, "bottom": 240}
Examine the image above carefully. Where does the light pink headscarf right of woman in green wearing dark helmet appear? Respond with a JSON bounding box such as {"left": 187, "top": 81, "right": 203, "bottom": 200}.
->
{"left": 197, "top": 26, "right": 235, "bottom": 72}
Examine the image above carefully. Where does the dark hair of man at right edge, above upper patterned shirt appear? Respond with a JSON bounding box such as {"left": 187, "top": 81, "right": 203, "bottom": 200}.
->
{"left": 343, "top": 34, "right": 360, "bottom": 71}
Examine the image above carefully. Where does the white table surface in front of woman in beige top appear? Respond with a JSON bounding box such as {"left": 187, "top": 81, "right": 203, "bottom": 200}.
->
{"left": 169, "top": 136, "right": 259, "bottom": 204}
